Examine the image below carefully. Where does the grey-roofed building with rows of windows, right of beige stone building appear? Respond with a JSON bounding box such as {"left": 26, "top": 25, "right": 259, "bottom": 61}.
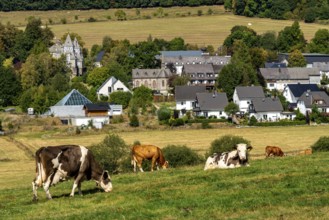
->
{"left": 182, "top": 64, "right": 218, "bottom": 90}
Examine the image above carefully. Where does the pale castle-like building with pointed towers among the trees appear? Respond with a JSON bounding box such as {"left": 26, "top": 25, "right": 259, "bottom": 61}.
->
{"left": 49, "top": 34, "right": 84, "bottom": 76}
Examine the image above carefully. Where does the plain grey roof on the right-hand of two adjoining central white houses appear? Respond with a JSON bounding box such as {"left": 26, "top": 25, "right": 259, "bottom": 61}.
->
{"left": 196, "top": 92, "right": 228, "bottom": 111}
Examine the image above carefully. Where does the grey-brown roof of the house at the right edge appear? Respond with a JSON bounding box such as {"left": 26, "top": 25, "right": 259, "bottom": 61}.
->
{"left": 298, "top": 91, "right": 329, "bottom": 108}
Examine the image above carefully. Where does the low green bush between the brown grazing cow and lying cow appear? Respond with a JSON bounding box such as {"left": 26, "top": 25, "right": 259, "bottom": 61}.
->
{"left": 162, "top": 145, "right": 203, "bottom": 167}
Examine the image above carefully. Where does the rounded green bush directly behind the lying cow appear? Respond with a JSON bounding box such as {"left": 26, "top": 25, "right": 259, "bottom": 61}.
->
{"left": 206, "top": 135, "right": 250, "bottom": 157}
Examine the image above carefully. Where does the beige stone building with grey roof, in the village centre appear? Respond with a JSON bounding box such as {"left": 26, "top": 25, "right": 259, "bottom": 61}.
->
{"left": 132, "top": 68, "right": 173, "bottom": 95}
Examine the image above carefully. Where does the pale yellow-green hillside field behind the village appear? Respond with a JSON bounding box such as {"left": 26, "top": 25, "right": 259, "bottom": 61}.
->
{"left": 0, "top": 6, "right": 328, "bottom": 49}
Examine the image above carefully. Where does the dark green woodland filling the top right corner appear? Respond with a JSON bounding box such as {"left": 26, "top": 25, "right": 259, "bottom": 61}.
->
{"left": 224, "top": 0, "right": 329, "bottom": 23}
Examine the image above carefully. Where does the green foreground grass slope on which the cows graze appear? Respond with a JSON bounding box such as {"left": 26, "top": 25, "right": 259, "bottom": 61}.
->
{"left": 0, "top": 153, "right": 329, "bottom": 219}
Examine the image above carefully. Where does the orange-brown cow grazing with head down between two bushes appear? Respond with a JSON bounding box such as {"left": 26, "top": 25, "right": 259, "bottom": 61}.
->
{"left": 131, "top": 145, "right": 169, "bottom": 172}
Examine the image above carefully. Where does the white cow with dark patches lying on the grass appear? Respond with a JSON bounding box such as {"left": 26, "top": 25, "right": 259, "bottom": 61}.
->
{"left": 204, "top": 144, "right": 252, "bottom": 170}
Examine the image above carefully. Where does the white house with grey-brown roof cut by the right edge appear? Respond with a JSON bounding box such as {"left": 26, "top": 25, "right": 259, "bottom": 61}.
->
{"left": 297, "top": 91, "right": 329, "bottom": 115}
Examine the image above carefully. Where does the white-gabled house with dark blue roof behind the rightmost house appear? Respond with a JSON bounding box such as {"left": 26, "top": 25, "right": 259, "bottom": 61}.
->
{"left": 282, "top": 83, "right": 320, "bottom": 103}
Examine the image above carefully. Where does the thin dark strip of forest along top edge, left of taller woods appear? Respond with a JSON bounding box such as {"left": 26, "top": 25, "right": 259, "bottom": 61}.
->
{"left": 0, "top": 0, "right": 224, "bottom": 11}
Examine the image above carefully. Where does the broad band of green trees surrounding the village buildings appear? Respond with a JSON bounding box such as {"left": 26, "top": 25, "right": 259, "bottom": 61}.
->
{"left": 0, "top": 17, "right": 329, "bottom": 113}
